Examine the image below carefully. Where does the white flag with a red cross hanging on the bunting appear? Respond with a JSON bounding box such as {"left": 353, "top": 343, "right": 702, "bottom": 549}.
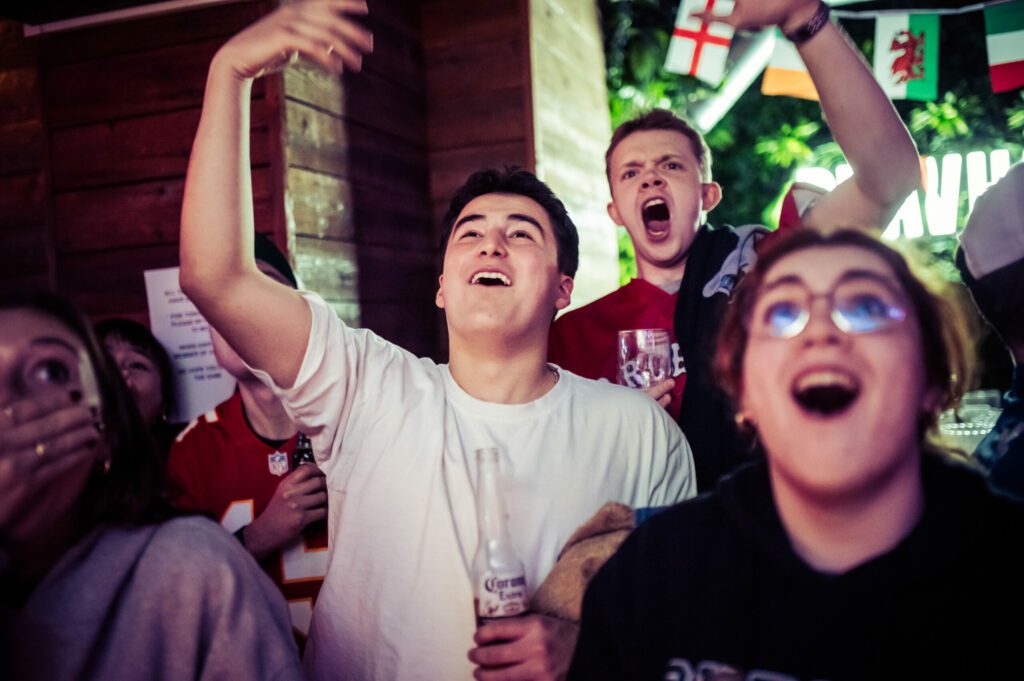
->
{"left": 665, "top": 0, "right": 733, "bottom": 85}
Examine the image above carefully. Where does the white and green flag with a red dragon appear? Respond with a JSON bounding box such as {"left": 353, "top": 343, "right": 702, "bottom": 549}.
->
{"left": 874, "top": 14, "right": 939, "bottom": 101}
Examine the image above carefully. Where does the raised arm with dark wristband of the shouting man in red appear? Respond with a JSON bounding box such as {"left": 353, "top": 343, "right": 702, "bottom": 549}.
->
{"left": 708, "top": 0, "right": 921, "bottom": 229}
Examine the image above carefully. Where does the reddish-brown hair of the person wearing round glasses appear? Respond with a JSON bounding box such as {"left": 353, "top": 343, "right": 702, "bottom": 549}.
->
{"left": 715, "top": 228, "right": 974, "bottom": 444}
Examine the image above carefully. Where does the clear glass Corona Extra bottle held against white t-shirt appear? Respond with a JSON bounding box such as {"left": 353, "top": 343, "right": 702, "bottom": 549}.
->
{"left": 472, "top": 448, "right": 527, "bottom": 627}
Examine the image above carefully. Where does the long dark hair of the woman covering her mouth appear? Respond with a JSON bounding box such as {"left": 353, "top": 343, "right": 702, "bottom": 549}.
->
{"left": 0, "top": 293, "right": 173, "bottom": 527}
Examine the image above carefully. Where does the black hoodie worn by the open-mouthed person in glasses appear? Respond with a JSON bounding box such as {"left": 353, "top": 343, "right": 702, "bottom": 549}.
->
{"left": 569, "top": 455, "right": 1024, "bottom": 681}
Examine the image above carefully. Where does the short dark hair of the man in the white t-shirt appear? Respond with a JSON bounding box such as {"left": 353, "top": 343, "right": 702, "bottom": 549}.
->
{"left": 441, "top": 166, "right": 580, "bottom": 276}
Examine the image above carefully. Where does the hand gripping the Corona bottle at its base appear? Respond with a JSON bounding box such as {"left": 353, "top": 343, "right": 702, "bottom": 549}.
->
{"left": 469, "top": 614, "right": 580, "bottom": 681}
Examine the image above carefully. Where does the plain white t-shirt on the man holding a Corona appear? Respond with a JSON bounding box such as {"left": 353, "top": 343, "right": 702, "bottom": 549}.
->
{"left": 256, "top": 293, "right": 696, "bottom": 681}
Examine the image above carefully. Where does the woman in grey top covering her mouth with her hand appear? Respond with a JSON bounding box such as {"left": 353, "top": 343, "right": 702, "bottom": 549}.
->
{"left": 0, "top": 295, "right": 302, "bottom": 681}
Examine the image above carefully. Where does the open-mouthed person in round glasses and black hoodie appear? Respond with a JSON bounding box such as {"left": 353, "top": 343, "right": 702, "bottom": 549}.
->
{"left": 569, "top": 229, "right": 1024, "bottom": 681}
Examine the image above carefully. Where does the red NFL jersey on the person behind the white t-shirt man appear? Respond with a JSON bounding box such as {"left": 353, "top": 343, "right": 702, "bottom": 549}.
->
{"left": 168, "top": 392, "right": 328, "bottom": 642}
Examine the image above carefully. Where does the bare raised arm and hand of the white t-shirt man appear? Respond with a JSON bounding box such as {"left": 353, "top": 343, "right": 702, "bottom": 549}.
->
{"left": 181, "top": 0, "right": 373, "bottom": 387}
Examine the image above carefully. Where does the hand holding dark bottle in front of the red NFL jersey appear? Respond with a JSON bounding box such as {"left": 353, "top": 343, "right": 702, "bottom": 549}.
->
{"left": 245, "top": 464, "right": 327, "bottom": 560}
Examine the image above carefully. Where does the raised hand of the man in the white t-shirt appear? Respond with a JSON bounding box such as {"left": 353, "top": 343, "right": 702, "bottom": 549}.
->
{"left": 215, "top": 0, "right": 374, "bottom": 80}
